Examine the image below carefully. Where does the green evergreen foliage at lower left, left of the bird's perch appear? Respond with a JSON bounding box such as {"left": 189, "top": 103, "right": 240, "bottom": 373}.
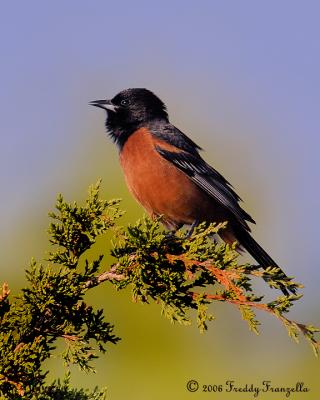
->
{"left": 0, "top": 183, "right": 121, "bottom": 399}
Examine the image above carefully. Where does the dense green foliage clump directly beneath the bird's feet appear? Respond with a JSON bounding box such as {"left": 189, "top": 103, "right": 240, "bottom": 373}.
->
{"left": 112, "top": 218, "right": 229, "bottom": 330}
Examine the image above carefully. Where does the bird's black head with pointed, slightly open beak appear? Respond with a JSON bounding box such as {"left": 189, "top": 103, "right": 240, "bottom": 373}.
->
{"left": 90, "top": 89, "right": 168, "bottom": 148}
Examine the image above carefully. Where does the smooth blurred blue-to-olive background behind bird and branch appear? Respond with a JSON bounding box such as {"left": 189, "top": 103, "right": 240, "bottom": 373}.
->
{"left": 0, "top": 0, "right": 320, "bottom": 400}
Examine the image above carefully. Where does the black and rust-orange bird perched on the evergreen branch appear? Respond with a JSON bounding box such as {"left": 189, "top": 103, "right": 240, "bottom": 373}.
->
{"left": 89, "top": 88, "right": 295, "bottom": 295}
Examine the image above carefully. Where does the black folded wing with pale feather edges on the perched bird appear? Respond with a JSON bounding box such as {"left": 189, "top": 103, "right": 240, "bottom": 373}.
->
{"left": 156, "top": 146, "right": 255, "bottom": 231}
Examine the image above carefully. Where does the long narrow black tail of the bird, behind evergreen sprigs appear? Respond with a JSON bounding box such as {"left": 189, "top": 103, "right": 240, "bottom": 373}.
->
{"left": 234, "top": 227, "right": 296, "bottom": 295}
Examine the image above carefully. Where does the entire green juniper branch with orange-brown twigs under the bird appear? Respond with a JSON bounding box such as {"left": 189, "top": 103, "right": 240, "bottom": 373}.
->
{"left": 0, "top": 182, "right": 319, "bottom": 400}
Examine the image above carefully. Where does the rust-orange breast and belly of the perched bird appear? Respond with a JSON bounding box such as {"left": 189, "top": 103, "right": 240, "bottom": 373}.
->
{"left": 120, "top": 128, "right": 226, "bottom": 227}
